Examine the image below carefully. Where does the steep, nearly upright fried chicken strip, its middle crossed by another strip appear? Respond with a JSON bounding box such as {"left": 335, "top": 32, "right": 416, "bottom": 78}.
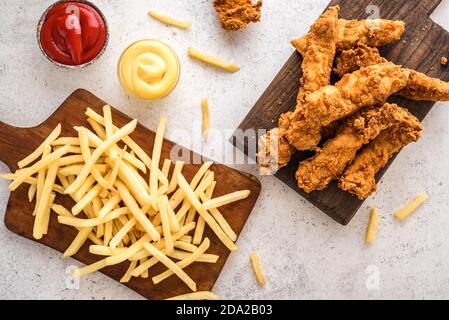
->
{"left": 257, "top": 6, "right": 340, "bottom": 175}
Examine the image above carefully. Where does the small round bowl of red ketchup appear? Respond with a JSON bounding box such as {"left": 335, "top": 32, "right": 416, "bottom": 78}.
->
{"left": 37, "top": 0, "right": 109, "bottom": 69}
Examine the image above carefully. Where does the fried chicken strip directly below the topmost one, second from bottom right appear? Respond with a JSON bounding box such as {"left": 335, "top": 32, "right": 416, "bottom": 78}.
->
{"left": 296, "top": 103, "right": 414, "bottom": 192}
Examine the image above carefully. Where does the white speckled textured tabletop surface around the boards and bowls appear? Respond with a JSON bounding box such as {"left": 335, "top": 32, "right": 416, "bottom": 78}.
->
{"left": 0, "top": 0, "right": 449, "bottom": 299}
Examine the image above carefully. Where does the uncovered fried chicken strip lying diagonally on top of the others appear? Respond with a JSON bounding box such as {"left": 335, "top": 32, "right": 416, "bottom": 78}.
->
{"left": 286, "top": 63, "right": 409, "bottom": 150}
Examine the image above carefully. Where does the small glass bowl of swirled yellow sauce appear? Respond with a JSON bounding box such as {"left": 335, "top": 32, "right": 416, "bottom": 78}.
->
{"left": 117, "top": 39, "right": 181, "bottom": 100}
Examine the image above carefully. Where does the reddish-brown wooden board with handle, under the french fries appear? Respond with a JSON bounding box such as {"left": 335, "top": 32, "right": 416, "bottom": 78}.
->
{"left": 0, "top": 89, "right": 260, "bottom": 299}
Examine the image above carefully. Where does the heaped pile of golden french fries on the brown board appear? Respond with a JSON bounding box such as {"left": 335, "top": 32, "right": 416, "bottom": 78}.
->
{"left": 2, "top": 106, "right": 250, "bottom": 291}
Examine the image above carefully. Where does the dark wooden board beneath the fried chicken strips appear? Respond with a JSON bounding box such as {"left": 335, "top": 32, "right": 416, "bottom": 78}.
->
{"left": 232, "top": 0, "right": 449, "bottom": 225}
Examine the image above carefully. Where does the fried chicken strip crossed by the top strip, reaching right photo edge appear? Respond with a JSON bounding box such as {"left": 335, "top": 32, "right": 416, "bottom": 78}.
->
{"left": 334, "top": 45, "right": 449, "bottom": 101}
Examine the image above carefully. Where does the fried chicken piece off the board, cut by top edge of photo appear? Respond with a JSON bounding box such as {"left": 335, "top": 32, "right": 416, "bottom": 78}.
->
{"left": 214, "top": 0, "right": 262, "bottom": 30}
